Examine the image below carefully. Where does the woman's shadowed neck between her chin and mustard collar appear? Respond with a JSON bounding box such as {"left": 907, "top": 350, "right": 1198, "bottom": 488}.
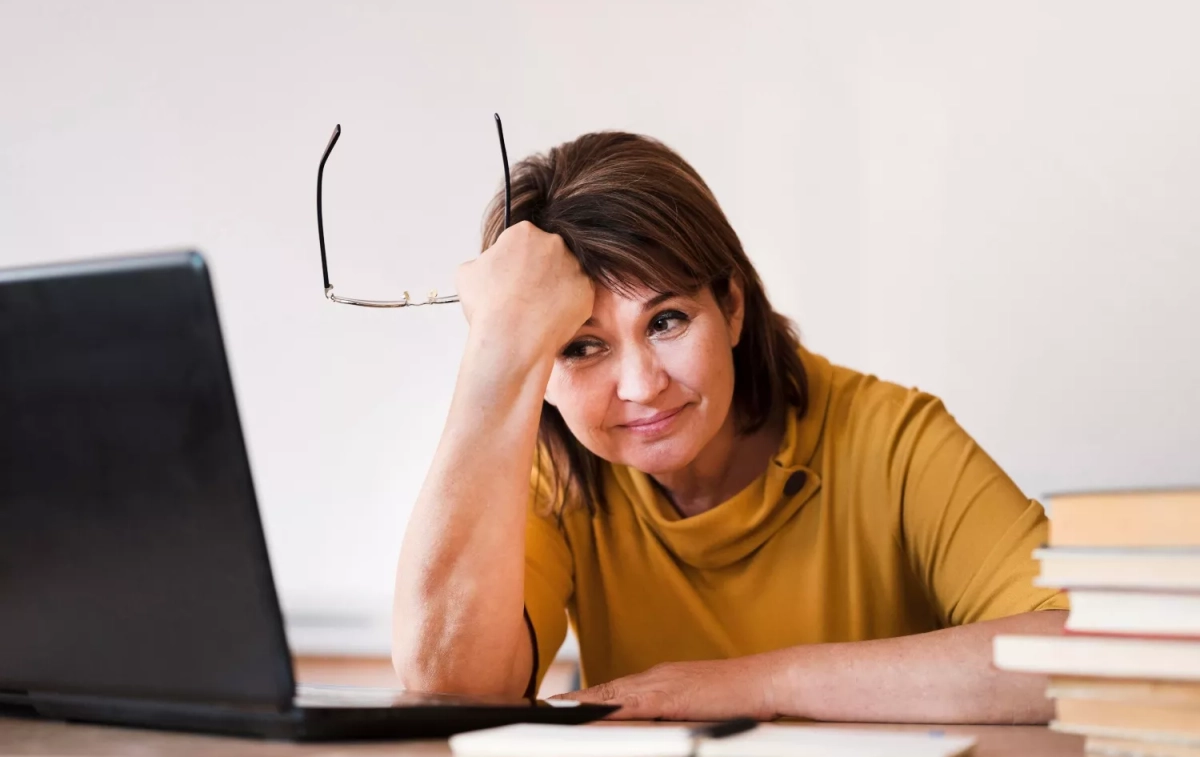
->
{"left": 654, "top": 408, "right": 786, "bottom": 518}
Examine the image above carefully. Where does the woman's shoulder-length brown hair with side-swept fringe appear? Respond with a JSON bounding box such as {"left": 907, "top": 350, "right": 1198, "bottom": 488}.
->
{"left": 484, "top": 132, "right": 808, "bottom": 512}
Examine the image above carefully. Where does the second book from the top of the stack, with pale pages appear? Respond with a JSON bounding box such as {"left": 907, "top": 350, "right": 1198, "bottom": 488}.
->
{"left": 1033, "top": 547, "right": 1200, "bottom": 591}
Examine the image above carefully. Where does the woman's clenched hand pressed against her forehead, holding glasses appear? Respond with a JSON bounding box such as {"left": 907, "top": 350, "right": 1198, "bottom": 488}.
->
{"left": 456, "top": 221, "right": 595, "bottom": 354}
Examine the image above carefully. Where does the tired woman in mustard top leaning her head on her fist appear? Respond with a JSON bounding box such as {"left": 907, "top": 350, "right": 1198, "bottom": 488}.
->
{"left": 394, "top": 133, "right": 1067, "bottom": 723}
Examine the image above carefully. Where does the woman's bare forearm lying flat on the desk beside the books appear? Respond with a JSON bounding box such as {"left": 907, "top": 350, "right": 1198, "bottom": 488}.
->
{"left": 758, "top": 611, "right": 1066, "bottom": 723}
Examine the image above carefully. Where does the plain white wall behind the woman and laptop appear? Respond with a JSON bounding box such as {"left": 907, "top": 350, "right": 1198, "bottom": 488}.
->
{"left": 0, "top": 0, "right": 1200, "bottom": 647}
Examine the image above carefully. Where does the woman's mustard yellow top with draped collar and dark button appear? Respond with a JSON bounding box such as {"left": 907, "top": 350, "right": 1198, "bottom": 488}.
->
{"left": 524, "top": 349, "right": 1068, "bottom": 685}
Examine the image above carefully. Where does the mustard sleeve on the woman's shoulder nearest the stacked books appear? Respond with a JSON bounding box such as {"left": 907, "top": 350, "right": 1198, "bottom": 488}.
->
{"left": 889, "top": 391, "right": 1068, "bottom": 626}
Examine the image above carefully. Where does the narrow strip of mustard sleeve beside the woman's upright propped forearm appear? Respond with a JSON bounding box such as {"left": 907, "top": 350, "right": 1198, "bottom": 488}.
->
{"left": 524, "top": 458, "right": 575, "bottom": 695}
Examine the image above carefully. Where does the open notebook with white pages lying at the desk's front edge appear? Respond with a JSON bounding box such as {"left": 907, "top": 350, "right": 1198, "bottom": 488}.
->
{"left": 450, "top": 725, "right": 974, "bottom": 757}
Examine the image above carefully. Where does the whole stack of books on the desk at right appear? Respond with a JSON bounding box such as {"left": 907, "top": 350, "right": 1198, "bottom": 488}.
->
{"left": 995, "top": 489, "right": 1200, "bottom": 757}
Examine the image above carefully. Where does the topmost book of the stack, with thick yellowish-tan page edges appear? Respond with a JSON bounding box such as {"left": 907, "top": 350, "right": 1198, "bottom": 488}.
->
{"left": 1048, "top": 489, "right": 1200, "bottom": 547}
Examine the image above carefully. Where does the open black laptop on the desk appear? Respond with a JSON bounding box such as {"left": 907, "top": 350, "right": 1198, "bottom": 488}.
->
{"left": 0, "top": 252, "right": 614, "bottom": 739}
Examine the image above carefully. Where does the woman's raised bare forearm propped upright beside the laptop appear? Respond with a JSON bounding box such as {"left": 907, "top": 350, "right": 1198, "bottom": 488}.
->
{"left": 392, "top": 332, "right": 552, "bottom": 695}
